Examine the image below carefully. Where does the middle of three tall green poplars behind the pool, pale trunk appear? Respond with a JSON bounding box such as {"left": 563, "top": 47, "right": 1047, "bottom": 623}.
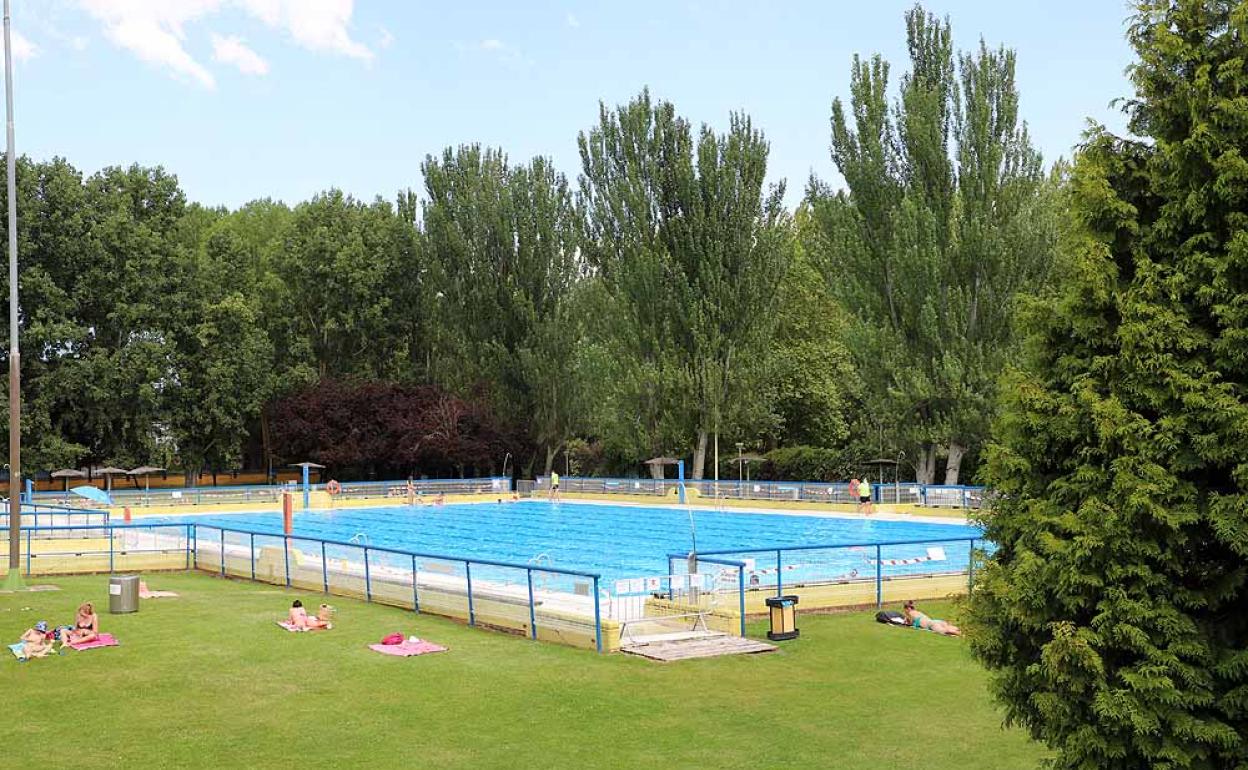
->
{"left": 579, "top": 91, "right": 791, "bottom": 478}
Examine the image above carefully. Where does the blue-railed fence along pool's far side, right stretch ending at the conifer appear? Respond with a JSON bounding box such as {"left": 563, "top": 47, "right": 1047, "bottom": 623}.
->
{"left": 531, "top": 475, "right": 985, "bottom": 508}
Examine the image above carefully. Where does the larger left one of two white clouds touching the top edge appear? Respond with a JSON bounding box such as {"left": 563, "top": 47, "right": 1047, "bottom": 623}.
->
{"left": 80, "top": 0, "right": 220, "bottom": 89}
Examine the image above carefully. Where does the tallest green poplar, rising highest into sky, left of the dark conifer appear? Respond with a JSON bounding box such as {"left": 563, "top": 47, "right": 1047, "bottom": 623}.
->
{"left": 810, "top": 6, "right": 1056, "bottom": 483}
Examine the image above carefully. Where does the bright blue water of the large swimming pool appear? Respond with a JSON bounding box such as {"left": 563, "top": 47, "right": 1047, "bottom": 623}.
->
{"left": 156, "top": 500, "right": 981, "bottom": 584}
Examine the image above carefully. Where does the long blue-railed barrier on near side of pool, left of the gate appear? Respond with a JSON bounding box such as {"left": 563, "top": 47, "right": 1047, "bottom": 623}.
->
{"left": 0, "top": 523, "right": 604, "bottom": 651}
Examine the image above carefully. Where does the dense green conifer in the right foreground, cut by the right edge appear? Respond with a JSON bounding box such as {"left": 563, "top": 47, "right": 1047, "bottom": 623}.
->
{"left": 968, "top": 0, "right": 1248, "bottom": 770}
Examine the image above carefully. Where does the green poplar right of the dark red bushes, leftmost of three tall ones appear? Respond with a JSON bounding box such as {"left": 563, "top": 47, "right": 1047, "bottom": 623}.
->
{"left": 423, "top": 146, "right": 584, "bottom": 473}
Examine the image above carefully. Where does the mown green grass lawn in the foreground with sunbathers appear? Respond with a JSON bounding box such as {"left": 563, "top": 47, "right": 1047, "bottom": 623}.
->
{"left": 0, "top": 574, "right": 1043, "bottom": 770}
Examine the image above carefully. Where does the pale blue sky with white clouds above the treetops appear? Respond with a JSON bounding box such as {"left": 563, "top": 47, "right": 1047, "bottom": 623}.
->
{"left": 12, "top": 0, "right": 1131, "bottom": 206}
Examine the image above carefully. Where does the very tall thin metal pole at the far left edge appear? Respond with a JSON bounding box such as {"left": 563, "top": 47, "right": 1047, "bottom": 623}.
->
{"left": 4, "top": 0, "right": 21, "bottom": 588}
